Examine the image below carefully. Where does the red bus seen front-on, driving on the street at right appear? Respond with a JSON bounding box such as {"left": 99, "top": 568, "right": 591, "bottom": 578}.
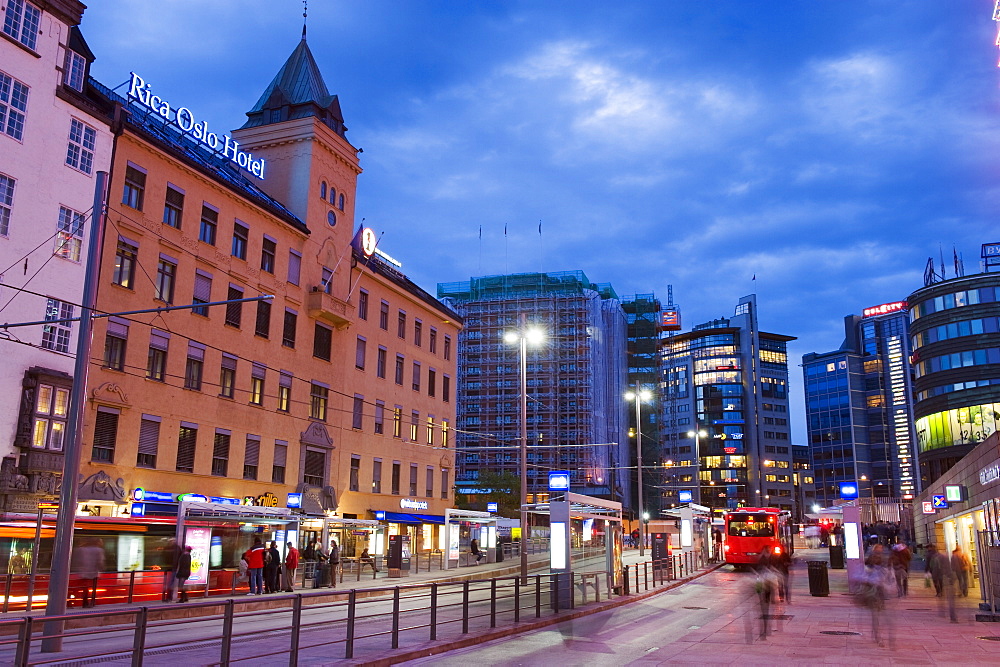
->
{"left": 723, "top": 507, "right": 793, "bottom": 568}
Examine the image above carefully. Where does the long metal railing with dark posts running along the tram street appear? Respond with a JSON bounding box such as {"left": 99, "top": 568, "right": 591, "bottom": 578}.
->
{"left": 0, "top": 552, "right": 704, "bottom": 667}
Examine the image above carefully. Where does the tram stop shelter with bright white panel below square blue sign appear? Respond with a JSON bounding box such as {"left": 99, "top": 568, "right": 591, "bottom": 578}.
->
{"left": 526, "top": 493, "right": 624, "bottom": 606}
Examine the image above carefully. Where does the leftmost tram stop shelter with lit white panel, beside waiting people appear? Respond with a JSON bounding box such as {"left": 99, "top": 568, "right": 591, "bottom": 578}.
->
{"left": 177, "top": 500, "right": 299, "bottom": 590}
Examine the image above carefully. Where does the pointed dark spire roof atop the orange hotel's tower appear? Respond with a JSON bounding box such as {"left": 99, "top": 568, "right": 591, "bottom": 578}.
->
{"left": 243, "top": 33, "right": 347, "bottom": 138}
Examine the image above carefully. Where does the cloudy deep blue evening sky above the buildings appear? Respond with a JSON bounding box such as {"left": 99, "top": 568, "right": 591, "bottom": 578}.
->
{"left": 82, "top": 0, "right": 1000, "bottom": 434}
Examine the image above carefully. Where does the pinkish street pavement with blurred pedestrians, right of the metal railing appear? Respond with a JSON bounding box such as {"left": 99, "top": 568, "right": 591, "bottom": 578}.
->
{"left": 403, "top": 550, "right": 1000, "bottom": 667}
